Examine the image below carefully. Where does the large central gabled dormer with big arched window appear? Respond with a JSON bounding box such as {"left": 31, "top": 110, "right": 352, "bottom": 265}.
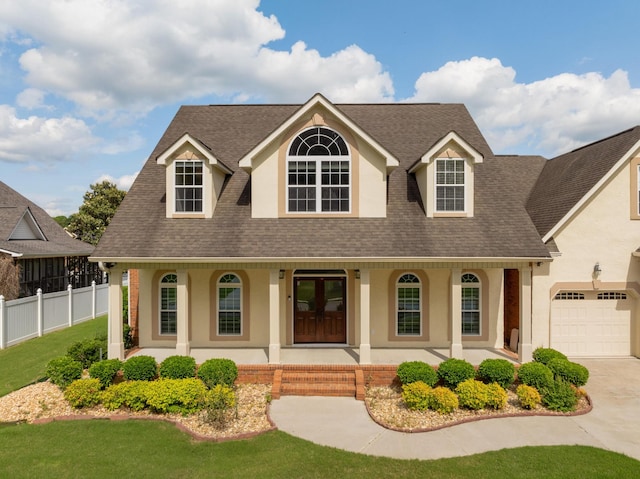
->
{"left": 239, "top": 94, "right": 399, "bottom": 218}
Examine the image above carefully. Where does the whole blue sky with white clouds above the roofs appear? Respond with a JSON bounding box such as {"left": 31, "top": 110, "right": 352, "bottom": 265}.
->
{"left": 0, "top": 0, "right": 640, "bottom": 216}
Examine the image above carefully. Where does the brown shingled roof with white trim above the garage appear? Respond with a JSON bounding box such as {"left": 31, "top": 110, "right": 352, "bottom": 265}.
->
{"left": 527, "top": 126, "right": 640, "bottom": 241}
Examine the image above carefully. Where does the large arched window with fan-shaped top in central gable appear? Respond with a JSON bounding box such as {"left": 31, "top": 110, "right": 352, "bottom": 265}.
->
{"left": 287, "top": 127, "right": 351, "bottom": 213}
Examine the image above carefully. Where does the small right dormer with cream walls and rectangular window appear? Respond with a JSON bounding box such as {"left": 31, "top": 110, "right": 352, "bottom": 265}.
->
{"left": 409, "top": 131, "right": 484, "bottom": 218}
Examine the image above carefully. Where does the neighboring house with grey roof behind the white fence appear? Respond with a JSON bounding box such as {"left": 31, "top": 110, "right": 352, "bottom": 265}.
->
{"left": 0, "top": 181, "right": 102, "bottom": 297}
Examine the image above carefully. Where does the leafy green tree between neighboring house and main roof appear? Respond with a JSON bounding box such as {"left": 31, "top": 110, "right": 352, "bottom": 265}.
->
{"left": 67, "top": 181, "right": 126, "bottom": 245}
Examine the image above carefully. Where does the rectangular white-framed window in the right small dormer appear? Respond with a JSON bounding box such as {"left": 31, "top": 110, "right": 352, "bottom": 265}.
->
{"left": 436, "top": 158, "right": 465, "bottom": 212}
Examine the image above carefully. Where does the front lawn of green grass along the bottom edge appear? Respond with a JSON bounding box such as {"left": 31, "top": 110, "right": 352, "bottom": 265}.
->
{"left": 0, "top": 420, "right": 640, "bottom": 479}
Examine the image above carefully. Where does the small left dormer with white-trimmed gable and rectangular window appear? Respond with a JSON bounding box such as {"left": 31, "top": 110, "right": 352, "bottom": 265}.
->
{"left": 156, "top": 133, "right": 232, "bottom": 218}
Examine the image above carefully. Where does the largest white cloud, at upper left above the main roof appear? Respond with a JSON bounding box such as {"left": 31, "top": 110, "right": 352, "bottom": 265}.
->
{"left": 0, "top": 0, "right": 393, "bottom": 118}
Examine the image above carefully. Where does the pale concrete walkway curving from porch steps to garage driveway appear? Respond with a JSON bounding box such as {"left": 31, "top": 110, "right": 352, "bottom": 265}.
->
{"left": 271, "top": 359, "right": 640, "bottom": 460}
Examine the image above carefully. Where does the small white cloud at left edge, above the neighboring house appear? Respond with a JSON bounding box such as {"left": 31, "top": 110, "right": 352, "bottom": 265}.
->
{"left": 0, "top": 105, "right": 99, "bottom": 163}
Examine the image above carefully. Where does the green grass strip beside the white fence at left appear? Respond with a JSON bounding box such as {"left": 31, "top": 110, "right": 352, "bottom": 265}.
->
{"left": 0, "top": 316, "right": 107, "bottom": 396}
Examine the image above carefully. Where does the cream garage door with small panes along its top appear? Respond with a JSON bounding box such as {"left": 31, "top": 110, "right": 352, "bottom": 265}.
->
{"left": 551, "top": 291, "right": 634, "bottom": 357}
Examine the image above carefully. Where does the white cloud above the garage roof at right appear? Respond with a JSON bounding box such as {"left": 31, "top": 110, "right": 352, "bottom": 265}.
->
{"left": 409, "top": 57, "right": 640, "bottom": 156}
